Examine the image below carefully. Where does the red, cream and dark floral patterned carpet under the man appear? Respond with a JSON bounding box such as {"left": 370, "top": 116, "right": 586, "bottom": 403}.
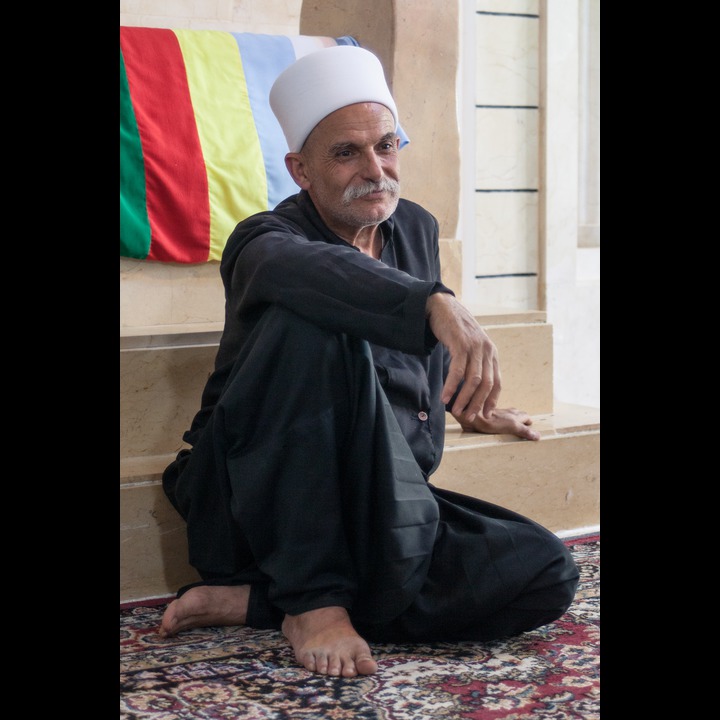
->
{"left": 120, "top": 535, "right": 600, "bottom": 720}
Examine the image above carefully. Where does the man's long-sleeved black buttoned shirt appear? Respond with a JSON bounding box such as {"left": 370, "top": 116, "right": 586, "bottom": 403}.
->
{"left": 184, "top": 191, "right": 451, "bottom": 476}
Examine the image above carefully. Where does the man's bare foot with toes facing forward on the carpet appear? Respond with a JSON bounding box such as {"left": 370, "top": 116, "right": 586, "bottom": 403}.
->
{"left": 282, "top": 607, "right": 377, "bottom": 677}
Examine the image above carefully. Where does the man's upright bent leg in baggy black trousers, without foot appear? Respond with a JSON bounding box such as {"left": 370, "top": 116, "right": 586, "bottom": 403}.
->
{"left": 209, "top": 308, "right": 438, "bottom": 618}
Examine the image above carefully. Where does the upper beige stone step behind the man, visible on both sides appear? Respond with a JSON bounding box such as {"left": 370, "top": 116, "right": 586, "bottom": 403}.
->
{"left": 120, "top": 309, "right": 553, "bottom": 458}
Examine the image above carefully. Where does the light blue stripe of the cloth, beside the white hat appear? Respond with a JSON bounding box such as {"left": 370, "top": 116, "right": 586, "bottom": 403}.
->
{"left": 232, "top": 33, "right": 299, "bottom": 210}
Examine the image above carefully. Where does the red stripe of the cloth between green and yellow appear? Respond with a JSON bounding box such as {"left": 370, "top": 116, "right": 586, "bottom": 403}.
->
{"left": 120, "top": 27, "right": 210, "bottom": 263}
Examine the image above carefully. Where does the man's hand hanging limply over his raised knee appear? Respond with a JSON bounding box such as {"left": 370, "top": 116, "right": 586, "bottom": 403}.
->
{"left": 426, "top": 292, "right": 502, "bottom": 425}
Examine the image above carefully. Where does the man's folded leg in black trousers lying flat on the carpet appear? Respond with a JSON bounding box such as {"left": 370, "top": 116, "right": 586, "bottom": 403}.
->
{"left": 356, "top": 488, "right": 579, "bottom": 642}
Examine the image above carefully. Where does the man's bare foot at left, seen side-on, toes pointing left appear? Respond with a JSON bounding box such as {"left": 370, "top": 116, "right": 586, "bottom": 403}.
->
{"left": 158, "top": 585, "right": 250, "bottom": 637}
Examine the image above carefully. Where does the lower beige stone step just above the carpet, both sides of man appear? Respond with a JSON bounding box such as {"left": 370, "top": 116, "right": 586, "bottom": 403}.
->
{"left": 120, "top": 406, "right": 600, "bottom": 603}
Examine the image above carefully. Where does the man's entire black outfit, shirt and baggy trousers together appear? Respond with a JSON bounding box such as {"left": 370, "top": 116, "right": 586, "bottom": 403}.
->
{"left": 163, "top": 191, "right": 577, "bottom": 640}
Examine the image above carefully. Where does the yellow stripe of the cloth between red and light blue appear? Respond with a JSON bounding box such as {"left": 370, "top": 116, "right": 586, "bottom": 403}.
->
{"left": 174, "top": 30, "right": 267, "bottom": 260}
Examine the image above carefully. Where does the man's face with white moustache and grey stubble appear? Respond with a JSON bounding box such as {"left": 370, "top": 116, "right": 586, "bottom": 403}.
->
{"left": 300, "top": 103, "right": 400, "bottom": 237}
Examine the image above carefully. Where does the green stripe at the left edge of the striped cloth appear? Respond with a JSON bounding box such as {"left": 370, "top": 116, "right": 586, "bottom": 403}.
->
{"left": 120, "top": 50, "right": 150, "bottom": 260}
